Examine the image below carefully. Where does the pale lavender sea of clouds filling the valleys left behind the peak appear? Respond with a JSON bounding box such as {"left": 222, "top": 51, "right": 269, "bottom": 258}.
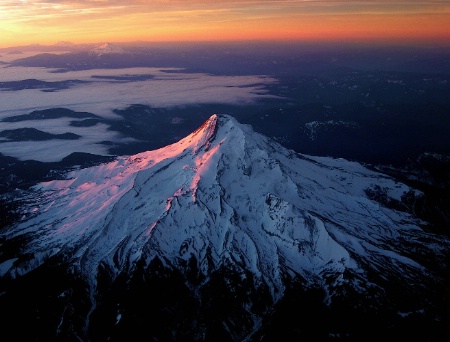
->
{"left": 0, "top": 58, "right": 277, "bottom": 162}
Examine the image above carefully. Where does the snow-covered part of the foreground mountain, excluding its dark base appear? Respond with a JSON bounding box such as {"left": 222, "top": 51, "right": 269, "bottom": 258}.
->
{"left": 0, "top": 115, "right": 448, "bottom": 340}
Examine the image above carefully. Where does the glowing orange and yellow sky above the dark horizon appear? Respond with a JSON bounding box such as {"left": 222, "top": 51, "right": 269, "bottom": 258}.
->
{"left": 0, "top": 0, "right": 450, "bottom": 48}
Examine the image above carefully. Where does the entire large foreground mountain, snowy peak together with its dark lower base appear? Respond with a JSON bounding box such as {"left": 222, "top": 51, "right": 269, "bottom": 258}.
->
{"left": 0, "top": 115, "right": 450, "bottom": 341}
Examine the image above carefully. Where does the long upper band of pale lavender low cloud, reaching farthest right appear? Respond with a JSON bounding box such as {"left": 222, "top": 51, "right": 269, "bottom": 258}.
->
{"left": 0, "top": 67, "right": 276, "bottom": 119}
